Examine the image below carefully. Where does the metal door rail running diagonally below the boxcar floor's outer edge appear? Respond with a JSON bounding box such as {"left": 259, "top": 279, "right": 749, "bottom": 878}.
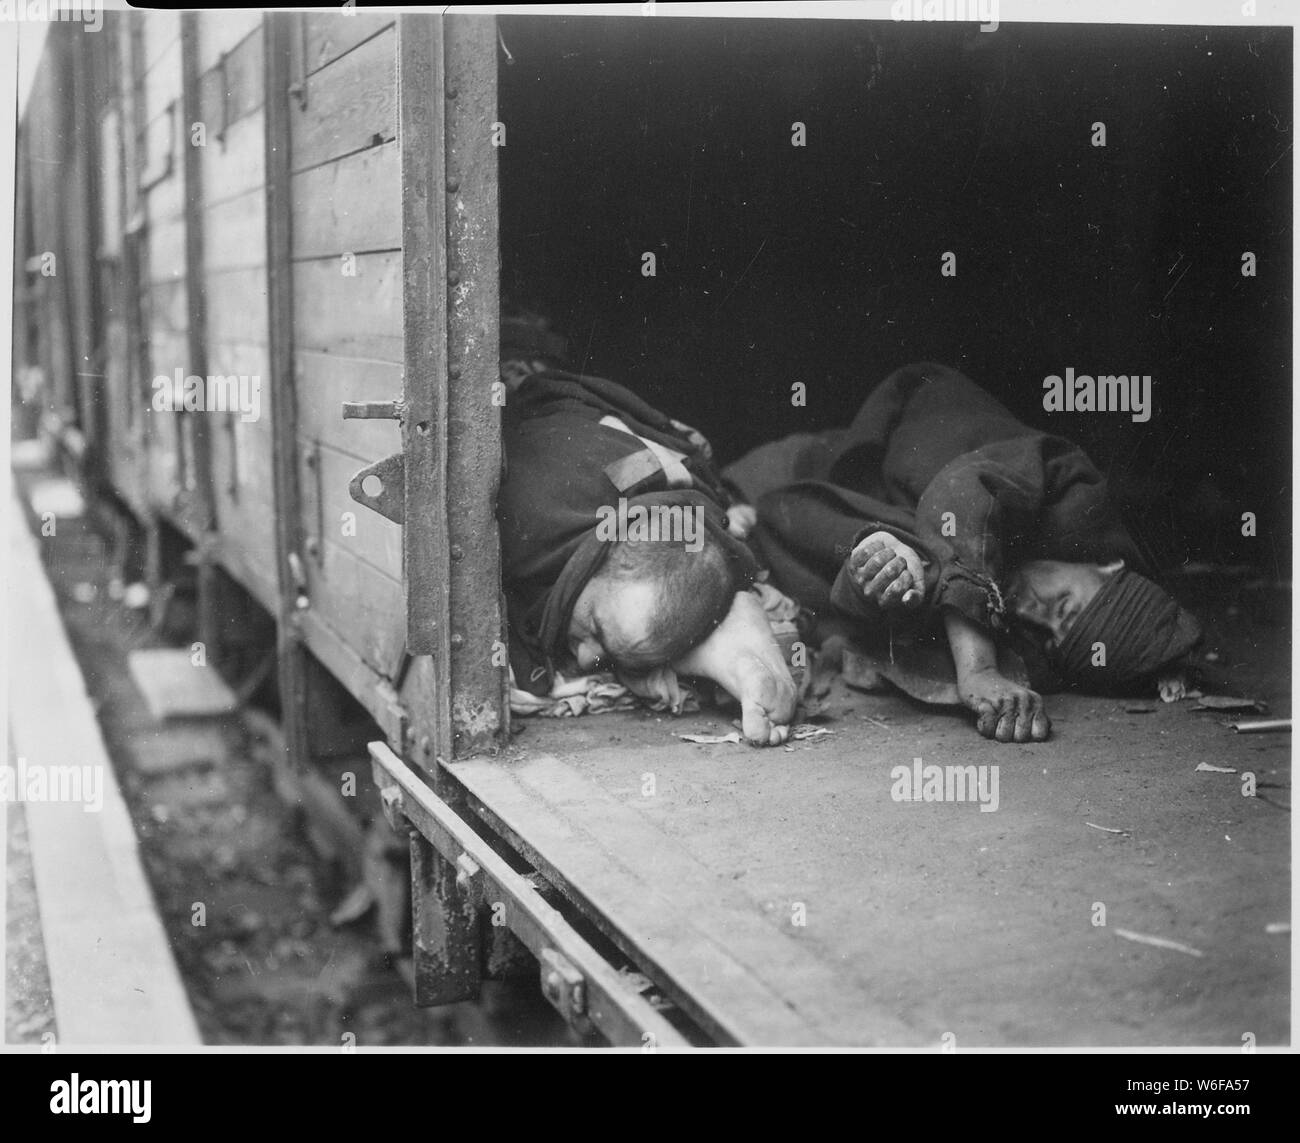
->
{"left": 369, "top": 742, "right": 689, "bottom": 1048}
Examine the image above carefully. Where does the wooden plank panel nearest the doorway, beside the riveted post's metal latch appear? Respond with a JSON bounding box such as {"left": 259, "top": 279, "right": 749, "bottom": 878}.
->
{"left": 290, "top": 12, "right": 406, "bottom": 679}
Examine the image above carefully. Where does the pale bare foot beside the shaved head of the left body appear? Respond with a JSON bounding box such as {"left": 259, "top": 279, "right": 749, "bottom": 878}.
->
{"left": 672, "top": 592, "right": 796, "bottom": 746}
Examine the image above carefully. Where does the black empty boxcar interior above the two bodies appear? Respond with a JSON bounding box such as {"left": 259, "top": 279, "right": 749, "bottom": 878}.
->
{"left": 499, "top": 17, "right": 1291, "bottom": 573}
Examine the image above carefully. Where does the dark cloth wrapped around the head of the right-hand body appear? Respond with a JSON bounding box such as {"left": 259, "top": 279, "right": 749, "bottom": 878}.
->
{"left": 1050, "top": 568, "right": 1201, "bottom": 690}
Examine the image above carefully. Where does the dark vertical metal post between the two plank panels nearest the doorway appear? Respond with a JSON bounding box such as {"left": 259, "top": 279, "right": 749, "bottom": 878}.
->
{"left": 263, "top": 12, "right": 308, "bottom": 767}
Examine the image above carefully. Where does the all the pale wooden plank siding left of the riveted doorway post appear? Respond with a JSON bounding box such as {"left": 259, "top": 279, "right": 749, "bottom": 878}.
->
{"left": 25, "top": 12, "right": 436, "bottom": 743}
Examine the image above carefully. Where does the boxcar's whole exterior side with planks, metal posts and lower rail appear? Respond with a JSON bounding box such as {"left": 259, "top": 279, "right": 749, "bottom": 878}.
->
{"left": 16, "top": 12, "right": 712, "bottom": 1043}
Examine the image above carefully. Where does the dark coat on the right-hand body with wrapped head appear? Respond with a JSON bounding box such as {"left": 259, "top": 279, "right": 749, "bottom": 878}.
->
{"left": 724, "top": 363, "right": 1143, "bottom": 629}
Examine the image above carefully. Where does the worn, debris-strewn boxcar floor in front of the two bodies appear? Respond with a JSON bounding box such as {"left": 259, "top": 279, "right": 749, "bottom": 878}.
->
{"left": 452, "top": 616, "right": 1290, "bottom": 1048}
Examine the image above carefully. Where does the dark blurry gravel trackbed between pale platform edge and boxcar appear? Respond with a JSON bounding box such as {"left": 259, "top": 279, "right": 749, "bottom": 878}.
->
{"left": 13, "top": 475, "right": 572, "bottom": 1047}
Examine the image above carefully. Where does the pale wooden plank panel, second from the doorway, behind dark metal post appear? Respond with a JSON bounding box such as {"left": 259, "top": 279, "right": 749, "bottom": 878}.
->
{"left": 198, "top": 10, "right": 278, "bottom": 612}
